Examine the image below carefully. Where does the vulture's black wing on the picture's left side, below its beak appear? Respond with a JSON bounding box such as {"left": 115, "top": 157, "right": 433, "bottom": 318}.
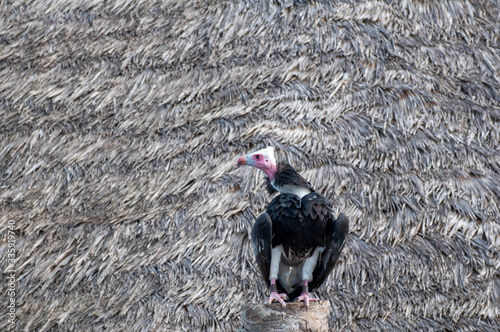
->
{"left": 252, "top": 213, "right": 273, "bottom": 287}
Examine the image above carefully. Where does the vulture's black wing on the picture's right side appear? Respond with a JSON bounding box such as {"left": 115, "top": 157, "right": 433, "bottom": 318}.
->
{"left": 309, "top": 213, "right": 349, "bottom": 292}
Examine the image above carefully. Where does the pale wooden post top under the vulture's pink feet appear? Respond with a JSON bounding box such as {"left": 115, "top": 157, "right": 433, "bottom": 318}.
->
{"left": 239, "top": 301, "right": 330, "bottom": 332}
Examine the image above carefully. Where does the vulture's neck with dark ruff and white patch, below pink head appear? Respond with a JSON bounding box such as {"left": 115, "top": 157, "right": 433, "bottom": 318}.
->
{"left": 267, "top": 163, "right": 314, "bottom": 198}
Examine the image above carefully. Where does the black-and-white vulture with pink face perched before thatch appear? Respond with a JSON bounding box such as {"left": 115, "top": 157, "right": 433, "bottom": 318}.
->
{"left": 238, "top": 147, "right": 349, "bottom": 310}
